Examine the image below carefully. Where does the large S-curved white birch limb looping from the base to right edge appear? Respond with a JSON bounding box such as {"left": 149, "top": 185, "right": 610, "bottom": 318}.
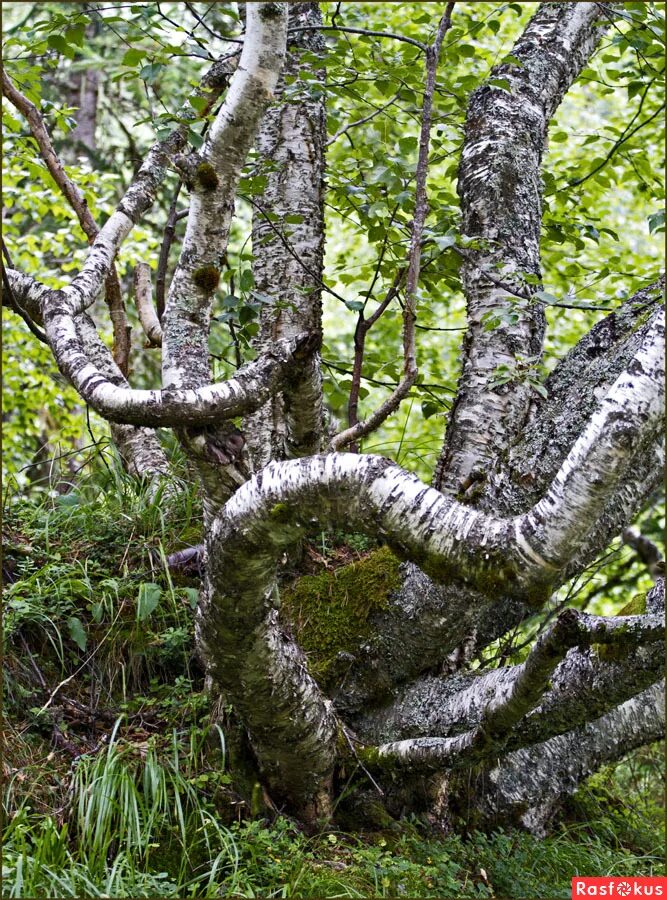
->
{"left": 197, "top": 317, "right": 664, "bottom": 809}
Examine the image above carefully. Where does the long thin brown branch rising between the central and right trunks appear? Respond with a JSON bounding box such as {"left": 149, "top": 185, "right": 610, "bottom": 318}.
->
{"left": 331, "top": 2, "right": 454, "bottom": 450}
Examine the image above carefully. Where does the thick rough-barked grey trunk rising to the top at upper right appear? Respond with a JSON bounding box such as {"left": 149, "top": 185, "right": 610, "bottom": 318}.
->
{"left": 433, "top": 3, "right": 604, "bottom": 494}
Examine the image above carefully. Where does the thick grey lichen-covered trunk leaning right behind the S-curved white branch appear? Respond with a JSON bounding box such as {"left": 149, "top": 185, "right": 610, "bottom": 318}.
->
{"left": 335, "top": 292, "right": 664, "bottom": 711}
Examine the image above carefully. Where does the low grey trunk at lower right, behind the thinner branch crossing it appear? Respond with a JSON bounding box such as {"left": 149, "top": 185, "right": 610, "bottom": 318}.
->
{"left": 352, "top": 583, "right": 665, "bottom": 752}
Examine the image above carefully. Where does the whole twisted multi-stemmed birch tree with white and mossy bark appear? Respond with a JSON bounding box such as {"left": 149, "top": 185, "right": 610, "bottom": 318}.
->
{"left": 3, "top": 2, "right": 664, "bottom": 832}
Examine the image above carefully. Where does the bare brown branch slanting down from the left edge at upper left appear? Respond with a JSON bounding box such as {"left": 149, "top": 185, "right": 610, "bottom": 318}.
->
{"left": 2, "top": 72, "right": 130, "bottom": 376}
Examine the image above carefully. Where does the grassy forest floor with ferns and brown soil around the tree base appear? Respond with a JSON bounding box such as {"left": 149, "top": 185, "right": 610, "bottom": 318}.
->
{"left": 2, "top": 465, "right": 664, "bottom": 900}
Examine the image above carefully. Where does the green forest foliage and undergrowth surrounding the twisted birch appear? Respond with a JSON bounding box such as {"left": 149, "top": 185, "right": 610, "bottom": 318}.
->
{"left": 2, "top": 2, "right": 664, "bottom": 898}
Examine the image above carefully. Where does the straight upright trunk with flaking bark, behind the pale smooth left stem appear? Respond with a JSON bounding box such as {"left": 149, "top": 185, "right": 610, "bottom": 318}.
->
{"left": 244, "top": 2, "right": 326, "bottom": 471}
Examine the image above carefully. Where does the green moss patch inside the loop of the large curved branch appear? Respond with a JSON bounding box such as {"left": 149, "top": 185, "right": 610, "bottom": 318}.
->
{"left": 278, "top": 544, "right": 400, "bottom": 688}
